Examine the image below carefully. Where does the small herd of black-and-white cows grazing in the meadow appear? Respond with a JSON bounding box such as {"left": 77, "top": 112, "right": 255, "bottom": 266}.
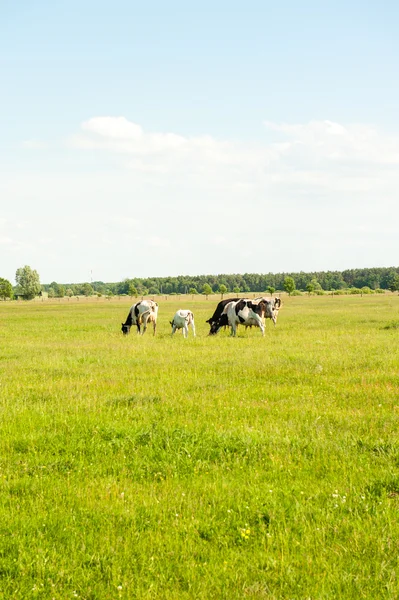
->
{"left": 122, "top": 297, "right": 281, "bottom": 337}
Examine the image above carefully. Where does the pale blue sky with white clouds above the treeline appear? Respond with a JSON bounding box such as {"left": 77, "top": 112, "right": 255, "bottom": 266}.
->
{"left": 0, "top": 0, "right": 399, "bottom": 284}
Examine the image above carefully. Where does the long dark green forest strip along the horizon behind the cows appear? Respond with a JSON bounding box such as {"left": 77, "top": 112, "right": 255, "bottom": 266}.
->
{"left": 42, "top": 267, "right": 399, "bottom": 296}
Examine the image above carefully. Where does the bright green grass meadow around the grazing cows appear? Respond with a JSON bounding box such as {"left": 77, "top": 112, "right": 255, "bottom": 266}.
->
{"left": 0, "top": 295, "right": 399, "bottom": 600}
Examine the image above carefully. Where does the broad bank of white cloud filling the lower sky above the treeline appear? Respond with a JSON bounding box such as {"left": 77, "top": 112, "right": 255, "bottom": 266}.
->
{"left": 4, "top": 117, "right": 399, "bottom": 281}
